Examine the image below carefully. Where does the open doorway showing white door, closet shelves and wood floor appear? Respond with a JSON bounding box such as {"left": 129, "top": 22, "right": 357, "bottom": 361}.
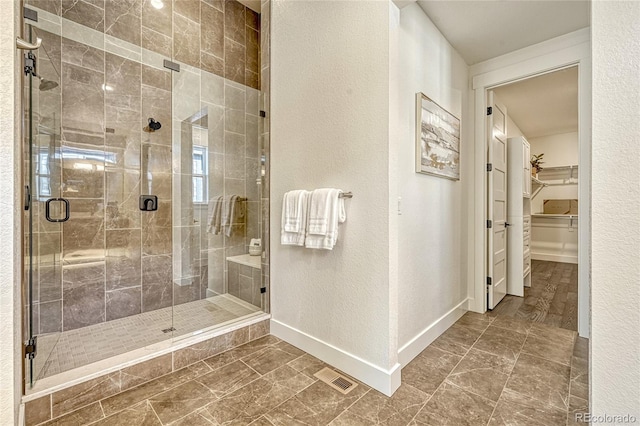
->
{"left": 487, "top": 66, "right": 581, "bottom": 331}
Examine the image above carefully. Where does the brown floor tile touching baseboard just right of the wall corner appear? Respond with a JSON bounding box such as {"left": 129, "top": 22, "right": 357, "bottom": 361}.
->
{"left": 402, "top": 346, "right": 462, "bottom": 395}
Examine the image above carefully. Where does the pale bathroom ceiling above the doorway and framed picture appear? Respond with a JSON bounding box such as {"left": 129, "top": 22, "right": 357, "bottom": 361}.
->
{"left": 417, "top": 0, "right": 589, "bottom": 65}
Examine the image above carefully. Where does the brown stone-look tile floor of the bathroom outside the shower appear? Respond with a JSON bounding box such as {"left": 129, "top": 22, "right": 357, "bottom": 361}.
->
{"left": 37, "top": 313, "right": 588, "bottom": 426}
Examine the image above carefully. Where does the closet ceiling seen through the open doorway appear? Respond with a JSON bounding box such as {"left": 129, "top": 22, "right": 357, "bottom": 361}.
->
{"left": 494, "top": 67, "right": 578, "bottom": 138}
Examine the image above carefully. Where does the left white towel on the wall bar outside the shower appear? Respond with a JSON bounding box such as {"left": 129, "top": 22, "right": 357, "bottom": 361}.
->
{"left": 280, "top": 190, "right": 310, "bottom": 246}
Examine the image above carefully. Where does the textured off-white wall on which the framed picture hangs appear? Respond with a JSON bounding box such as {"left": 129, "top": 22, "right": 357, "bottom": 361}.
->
{"left": 391, "top": 4, "right": 473, "bottom": 347}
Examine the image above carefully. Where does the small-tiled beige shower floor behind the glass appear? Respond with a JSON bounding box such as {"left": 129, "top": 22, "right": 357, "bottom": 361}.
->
{"left": 34, "top": 294, "right": 261, "bottom": 379}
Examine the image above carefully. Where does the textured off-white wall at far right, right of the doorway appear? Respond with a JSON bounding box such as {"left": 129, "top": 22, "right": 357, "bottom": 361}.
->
{"left": 590, "top": 1, "right": 640, "bottom": 424}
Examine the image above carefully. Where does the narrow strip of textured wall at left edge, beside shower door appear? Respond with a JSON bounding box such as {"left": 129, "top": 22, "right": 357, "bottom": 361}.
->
{"left": 0, "top": 1, "right": 22, "bottom": 425}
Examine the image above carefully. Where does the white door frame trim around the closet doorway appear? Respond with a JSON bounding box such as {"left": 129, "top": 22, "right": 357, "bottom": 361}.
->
{"left": 468, "top": 28, "right": 591, "bottom": 337}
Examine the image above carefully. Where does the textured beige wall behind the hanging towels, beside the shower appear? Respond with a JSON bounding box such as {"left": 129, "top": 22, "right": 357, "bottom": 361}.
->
{"left": 271, "top": 1, "right": 397, "bottom": 378}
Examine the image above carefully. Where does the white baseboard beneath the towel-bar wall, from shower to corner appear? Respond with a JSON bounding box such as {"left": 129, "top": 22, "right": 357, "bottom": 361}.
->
{"left": 271, "top": 318, "right": 400, "bottom": 396}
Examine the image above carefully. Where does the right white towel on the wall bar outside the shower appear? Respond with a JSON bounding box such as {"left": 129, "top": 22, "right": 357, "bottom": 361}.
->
{"left": 304, "top": 188, "right": 347, "bottom": 250}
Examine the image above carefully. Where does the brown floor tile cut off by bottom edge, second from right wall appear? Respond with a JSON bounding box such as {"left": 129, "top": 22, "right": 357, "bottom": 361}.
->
{"left": 489, "top": 389, "right": 566, "bottom": 426}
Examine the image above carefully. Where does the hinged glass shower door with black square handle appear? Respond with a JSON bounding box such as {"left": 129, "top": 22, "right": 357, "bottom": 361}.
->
{"left": 23, "top": 20, "right": 64, "bottom": 386}
